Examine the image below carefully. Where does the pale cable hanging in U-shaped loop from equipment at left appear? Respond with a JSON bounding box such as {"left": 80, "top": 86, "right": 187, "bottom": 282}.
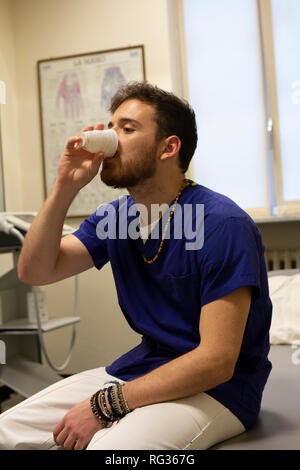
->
{"left": 0, "top": 218, "right": 78, "bottom": 372}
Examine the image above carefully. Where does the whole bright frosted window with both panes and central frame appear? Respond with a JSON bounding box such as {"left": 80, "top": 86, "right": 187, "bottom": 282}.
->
{"left": 182, "top": 0, "right": 300, "bottom": 216}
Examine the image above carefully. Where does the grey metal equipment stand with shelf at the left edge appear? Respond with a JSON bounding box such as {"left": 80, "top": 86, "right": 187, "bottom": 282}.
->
{"left": 0, "top": 233, "right": 80, "bottom": 404}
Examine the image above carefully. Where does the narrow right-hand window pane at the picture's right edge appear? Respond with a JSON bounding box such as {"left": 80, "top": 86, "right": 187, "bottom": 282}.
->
{"left": 271, "top": 0, "right": 300, "bottom": 210}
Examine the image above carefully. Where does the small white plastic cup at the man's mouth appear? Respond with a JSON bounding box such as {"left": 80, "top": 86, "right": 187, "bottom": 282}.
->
{"left": 80, "top": 129, "right": 118, "bottom": 157}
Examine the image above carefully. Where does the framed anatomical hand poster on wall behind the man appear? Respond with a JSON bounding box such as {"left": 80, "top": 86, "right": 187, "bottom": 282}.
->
{"left": 38, "top": 46, "right": 145, "bottom": 216}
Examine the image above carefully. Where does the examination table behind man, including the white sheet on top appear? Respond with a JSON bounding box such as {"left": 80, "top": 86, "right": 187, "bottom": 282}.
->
{"left": 213, "top": 269, "right": 300, "bottom": 450}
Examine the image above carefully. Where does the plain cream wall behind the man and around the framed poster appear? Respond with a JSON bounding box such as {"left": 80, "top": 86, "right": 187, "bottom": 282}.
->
{"left": 0, "top": 0, "right": 176, "bottom": 373}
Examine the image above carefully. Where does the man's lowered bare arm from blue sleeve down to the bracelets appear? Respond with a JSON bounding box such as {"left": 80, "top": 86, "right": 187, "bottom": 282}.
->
{"left": 124, "top": 287, "right": 251, "bottom": 410}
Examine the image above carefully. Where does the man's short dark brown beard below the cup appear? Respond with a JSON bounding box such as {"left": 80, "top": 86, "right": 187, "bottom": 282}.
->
{"left": 100, "top": 145, "right": 157, "bottom": 189}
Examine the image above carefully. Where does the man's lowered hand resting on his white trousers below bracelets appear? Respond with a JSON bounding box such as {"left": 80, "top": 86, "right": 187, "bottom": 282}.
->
{"left": 53, "top": 398, "right": 103, "bottom": 450}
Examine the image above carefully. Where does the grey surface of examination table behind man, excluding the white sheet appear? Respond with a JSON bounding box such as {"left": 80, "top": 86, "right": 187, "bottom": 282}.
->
{"left": 212, "top": 344, "right": 300, "bottom": 450}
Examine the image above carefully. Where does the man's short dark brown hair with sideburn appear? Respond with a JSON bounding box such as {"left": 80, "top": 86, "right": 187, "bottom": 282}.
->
{"left": 110, "top": 82, "right": 198, "bottom": 173}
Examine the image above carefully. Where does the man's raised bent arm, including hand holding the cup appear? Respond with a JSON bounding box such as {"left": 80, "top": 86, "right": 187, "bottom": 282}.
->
{"left": 18, "top": 125, "right": 103, "bottom": 285}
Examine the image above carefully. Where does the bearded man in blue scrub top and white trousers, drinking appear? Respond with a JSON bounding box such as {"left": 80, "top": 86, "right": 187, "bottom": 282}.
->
{"left": 0, "top": 83, "right": 272, "bottom": 450}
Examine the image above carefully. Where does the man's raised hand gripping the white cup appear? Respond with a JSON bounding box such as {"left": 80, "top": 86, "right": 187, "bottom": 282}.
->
{"left": 57, "top": 124, "right": 104, "bottom": 191}
